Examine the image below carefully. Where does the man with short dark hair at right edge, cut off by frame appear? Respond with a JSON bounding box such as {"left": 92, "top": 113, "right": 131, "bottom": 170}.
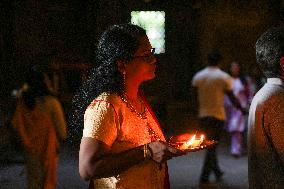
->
{"left": 248, "top": 27, "right": 284, "bottom": 189}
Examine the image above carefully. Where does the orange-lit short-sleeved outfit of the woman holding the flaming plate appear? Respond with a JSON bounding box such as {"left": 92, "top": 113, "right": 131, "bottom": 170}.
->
{"left": 83, "top": 93, "right": 169, "bottom": 189}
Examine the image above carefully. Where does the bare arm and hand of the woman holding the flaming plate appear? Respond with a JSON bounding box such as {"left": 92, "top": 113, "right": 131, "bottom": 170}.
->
{"left": 79, "top": 137, "right": 184, "bottom": 180}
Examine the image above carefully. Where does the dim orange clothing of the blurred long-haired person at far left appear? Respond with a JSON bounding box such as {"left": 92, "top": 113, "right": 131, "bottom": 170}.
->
{"left": 12, "top": 97, "right": 66, "bottom": 189}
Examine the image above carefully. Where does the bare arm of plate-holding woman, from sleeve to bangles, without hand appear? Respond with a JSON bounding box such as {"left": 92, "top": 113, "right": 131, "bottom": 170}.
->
{"left": 79, "top": 137, "right": 144, "bottom": 180}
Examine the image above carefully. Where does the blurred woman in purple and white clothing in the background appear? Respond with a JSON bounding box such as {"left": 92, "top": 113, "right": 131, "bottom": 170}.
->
{"left": 225, "top": 61, "right": 254, "bottom": 157}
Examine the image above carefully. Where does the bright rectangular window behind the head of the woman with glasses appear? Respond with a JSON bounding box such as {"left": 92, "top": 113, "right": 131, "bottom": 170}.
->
{"left": 131, "top": 11, "right": 165, "bottom": 54}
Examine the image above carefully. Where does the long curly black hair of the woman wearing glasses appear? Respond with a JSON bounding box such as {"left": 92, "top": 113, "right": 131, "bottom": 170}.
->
{"left": 69, "top": 24, "right": 146, "bottom": 144}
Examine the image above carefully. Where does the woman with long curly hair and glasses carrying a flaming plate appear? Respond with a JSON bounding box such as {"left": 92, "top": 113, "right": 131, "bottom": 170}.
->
{"left": 74, "top": 24, "right": 184, "bottom": 189}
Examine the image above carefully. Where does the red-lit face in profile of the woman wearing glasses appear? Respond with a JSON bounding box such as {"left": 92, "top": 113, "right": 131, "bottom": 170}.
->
{"left": 125, "top": 36, "right": 157, "bottom": 83}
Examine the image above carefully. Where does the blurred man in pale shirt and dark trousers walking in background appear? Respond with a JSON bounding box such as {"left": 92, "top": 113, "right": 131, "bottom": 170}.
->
{"left": 191, "top": 51, "right": 245, "bottom": 185}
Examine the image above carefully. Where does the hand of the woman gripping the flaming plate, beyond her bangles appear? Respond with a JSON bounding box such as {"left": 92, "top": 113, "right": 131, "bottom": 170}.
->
{"left": 148, "top": 141, "right": 186, "bottom": 163}
